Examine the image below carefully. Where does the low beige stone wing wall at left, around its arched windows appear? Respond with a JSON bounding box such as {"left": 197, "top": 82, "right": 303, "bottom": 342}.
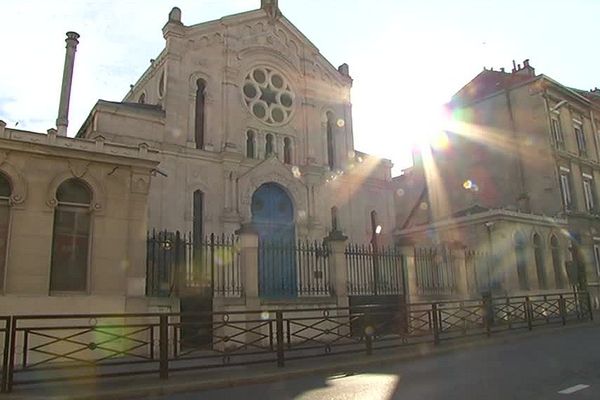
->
{"left": 0, "top": 121, "right": 176, "bottom": 314}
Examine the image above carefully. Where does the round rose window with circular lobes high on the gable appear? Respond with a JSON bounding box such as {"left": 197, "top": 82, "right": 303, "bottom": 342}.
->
{"left": 242, "top": 67, "right": 294, "bottom": 125}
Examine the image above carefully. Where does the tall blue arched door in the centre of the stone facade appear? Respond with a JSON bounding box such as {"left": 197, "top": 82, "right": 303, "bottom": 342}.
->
{"left": 251, "top": 182, "right": 297, "bottom": 298}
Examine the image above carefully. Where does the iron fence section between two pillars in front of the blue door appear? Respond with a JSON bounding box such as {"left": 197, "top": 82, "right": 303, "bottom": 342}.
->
{"left": 258, "top": 240, "right": 331, "bottom": 297}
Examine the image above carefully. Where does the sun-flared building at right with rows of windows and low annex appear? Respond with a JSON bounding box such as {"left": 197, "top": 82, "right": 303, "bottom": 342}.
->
{"left": 394, "top": 60, "right": 600, "bottom": 300}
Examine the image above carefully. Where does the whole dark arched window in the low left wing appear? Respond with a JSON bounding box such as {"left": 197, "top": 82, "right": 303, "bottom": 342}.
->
{"left": 50, "top": 178, "right": 92, "bottom": 292}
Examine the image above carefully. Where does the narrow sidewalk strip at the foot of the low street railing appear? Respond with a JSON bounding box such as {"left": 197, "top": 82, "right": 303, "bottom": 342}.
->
{"left": 0, "top": 322, "right": 598, "bottom": 400}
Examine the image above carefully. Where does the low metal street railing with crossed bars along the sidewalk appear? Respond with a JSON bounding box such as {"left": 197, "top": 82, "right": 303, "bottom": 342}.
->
{"left": 0, "top": 293, "right": 592, "bottom": 392}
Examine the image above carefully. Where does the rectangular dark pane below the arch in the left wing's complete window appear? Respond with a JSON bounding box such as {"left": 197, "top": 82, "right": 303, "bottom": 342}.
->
{"left": 50, "top": 209, "right": 90, "bottom": 291}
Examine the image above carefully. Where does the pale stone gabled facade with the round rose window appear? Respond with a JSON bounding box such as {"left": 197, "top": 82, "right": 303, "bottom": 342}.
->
{"left": 78, "top": 3, "right": 394, "bottom": 243}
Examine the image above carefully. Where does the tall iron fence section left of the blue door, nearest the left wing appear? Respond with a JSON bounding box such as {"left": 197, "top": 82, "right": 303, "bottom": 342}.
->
{"left": 146, "top": 231, "right": 243, "bottom": 297}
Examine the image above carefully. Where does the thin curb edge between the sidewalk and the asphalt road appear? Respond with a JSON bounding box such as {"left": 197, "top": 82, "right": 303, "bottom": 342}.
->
{"left": 7, "top": 321, "right": 599, "bottom": 400}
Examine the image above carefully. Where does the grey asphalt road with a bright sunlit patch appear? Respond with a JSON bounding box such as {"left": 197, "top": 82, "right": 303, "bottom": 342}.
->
{"left": 151, "top": 325, "right": 600, "bottom": 400}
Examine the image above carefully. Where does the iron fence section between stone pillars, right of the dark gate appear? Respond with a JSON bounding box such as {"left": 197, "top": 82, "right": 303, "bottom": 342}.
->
{"left": 414, "top": 247, "right": 457, "bottom": 295}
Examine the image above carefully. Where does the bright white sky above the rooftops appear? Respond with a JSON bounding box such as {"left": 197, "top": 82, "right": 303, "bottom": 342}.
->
{"left": 0, "top": 0, "right": 600, "bottom": 174}
